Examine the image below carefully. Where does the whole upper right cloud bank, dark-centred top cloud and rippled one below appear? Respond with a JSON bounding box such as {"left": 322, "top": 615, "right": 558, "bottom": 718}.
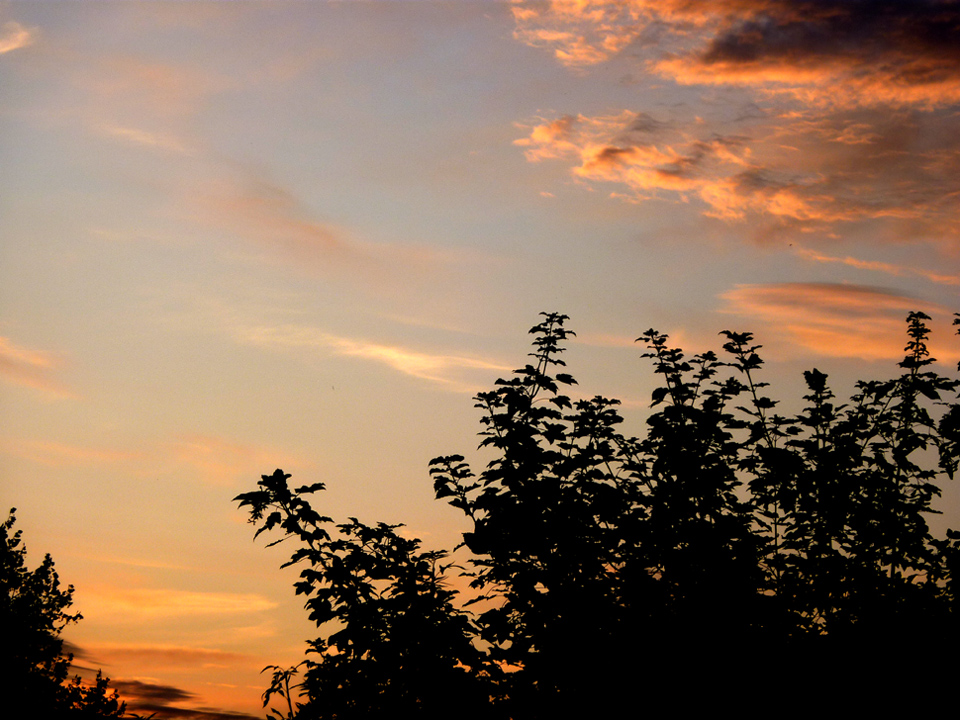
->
{"left": 513, "top": 0, "right": 960, "bottom": 242}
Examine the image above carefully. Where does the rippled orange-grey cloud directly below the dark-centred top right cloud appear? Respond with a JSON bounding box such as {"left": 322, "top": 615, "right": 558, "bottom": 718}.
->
{"left": 514, "top": 106, "right": 960, "bottom": 240}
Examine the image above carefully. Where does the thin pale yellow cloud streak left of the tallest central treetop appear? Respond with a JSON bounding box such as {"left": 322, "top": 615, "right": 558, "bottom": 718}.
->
{"left": 236, "top": 324, "right": 510, "bottom": 392}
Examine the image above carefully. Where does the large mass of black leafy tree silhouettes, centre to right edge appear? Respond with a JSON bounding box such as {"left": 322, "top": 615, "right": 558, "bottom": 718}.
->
{"left": 236, "top": 313, "right": 960, "bottom": 718}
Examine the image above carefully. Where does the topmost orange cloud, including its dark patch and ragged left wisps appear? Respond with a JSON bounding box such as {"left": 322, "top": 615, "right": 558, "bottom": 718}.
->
{"left": 513, "top": 0, "right": 960, "bottom": 107}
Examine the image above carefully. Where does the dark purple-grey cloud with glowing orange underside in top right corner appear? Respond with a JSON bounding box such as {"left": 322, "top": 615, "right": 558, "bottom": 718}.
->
{"left": 651, "top": 0, "right": 960, "bottom": 108}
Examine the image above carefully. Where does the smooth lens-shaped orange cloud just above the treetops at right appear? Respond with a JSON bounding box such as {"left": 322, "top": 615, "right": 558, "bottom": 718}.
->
{"left": 720, "top": 283, "right": 960, "bottom": 362}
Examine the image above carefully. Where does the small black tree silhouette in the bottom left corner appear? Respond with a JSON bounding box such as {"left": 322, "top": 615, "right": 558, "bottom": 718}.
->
{"left": 0, "top": 508, "right": 125, "bottom": 718}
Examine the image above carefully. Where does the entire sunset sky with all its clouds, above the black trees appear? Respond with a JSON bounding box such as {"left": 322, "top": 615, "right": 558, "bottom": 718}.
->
{"left": 0, "top": 0, "right": 960, "bottom": 720}
